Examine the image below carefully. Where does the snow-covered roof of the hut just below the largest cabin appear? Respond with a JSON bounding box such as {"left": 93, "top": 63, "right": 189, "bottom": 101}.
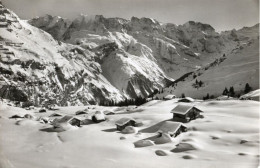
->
{"left": 158, "top": 121, "right": 186, "bottom": 134}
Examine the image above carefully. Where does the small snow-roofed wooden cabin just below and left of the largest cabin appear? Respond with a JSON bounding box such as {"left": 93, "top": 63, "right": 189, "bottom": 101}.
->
{"left": 158, "top": 121, "right": 187, "bottom": 137}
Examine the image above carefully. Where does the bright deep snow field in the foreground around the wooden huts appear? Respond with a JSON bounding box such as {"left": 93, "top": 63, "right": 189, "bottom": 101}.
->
{"left": 0, "top": 100, "right": 260, "bottom": 168}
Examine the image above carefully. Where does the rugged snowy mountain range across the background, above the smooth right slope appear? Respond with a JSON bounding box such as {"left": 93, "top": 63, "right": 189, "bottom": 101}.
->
{"left": 0, "top": 0, "right": 259, "bottom": 105}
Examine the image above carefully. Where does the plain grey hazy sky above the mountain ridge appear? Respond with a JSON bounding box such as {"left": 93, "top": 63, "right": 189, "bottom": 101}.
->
{"left": 2, "top": 0, "right": 259, "bottom": 31}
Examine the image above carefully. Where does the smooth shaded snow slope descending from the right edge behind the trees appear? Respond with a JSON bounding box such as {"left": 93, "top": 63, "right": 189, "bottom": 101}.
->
{"left": 156, "top": 25, "right": 259, "bottom": 98}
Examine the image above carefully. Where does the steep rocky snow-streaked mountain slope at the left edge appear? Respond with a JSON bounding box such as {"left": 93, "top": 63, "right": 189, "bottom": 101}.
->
{"left": 0, "top": 2, "right": 126, "bottom": 105}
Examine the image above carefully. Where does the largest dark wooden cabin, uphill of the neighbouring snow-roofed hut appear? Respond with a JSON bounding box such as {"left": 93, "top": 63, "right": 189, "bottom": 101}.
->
{"left": 171, "top": 104, "right": 203, "bottom": 122}
